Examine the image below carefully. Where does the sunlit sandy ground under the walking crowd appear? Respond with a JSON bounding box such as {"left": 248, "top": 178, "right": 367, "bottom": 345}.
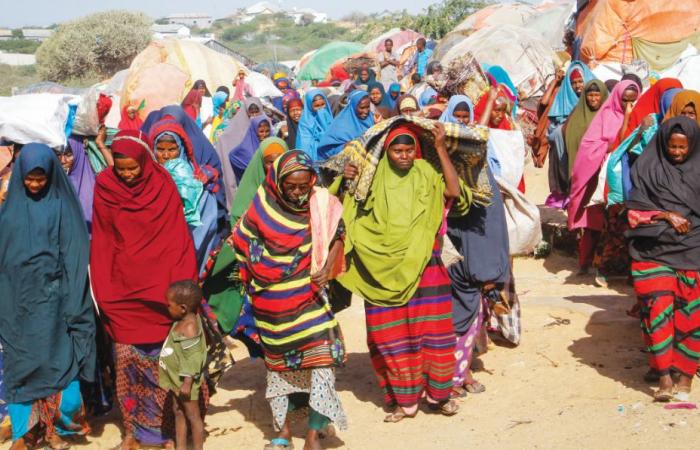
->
{"left": 1, "top": 163, "right": 700, "bottom": 450}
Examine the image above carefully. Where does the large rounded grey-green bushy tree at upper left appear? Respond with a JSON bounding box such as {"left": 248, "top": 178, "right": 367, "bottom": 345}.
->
{"left": 36, "top": 11, "right": 151, "bottom": 82}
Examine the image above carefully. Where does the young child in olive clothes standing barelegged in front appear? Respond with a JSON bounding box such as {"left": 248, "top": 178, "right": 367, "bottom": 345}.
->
{"left": 159, "top": 280, "right": 207, "bottom": 450}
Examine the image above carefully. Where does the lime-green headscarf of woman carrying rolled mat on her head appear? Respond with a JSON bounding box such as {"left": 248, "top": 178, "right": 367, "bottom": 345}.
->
{"left": 338, "top": 153, "right": 471, "bottom": 306}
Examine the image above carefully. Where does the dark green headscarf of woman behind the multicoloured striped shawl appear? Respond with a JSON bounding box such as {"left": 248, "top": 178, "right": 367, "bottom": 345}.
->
{"left": 203, "top": 137, "right": 288, "bottom": 334}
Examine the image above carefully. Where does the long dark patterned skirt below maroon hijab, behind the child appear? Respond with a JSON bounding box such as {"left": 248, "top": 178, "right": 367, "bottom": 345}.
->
{"left": 114, "top": 343, "right": 175, "bottom": 446}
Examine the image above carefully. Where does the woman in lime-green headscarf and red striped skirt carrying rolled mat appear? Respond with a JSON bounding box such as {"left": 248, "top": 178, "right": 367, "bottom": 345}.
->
{"left": 339, "top": 123, "right": 471, "bottom": 422}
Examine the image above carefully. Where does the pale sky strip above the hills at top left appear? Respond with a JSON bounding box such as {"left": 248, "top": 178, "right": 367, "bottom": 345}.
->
{"left": 0, "top": 0, "right": 448, "bottom": 28}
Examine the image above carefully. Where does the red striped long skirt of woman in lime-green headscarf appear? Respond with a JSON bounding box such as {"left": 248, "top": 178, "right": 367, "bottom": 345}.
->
{"left": 365, "top": 246, "right": 456, "bottom": 407}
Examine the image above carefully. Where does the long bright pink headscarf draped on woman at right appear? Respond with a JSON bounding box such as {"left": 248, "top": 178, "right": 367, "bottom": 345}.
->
{"left": 568, "top": 80, "right": 637, "bottom": 230}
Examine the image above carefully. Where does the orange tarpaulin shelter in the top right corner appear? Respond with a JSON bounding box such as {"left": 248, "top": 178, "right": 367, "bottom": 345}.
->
{"left": 576, "top": 0, "right": 700, "bottom": 70}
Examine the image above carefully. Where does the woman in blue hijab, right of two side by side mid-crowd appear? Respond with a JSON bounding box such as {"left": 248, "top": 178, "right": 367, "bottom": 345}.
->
{"left": 318, "top": 90, "right": 374, "bottom": 161}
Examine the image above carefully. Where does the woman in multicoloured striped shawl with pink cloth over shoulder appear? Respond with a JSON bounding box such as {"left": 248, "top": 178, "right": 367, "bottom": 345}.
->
{"left": 232, "top": 150, "right": 346, "bottom": 450}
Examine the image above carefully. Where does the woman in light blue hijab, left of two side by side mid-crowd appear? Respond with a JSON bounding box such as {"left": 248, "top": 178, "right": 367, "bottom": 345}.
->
{"left": 296, "top": 89, "right": 333, "bottom": 162}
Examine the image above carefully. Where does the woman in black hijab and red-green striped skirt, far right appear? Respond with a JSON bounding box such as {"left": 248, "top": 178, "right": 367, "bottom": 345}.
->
{"left": 626, "top": 116, "right": 700, "bottom": 402}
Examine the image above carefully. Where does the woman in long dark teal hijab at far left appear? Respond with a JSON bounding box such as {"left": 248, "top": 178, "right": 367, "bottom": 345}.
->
{"left": 0, "top": 144, "right": 96, "bottom": 448}
